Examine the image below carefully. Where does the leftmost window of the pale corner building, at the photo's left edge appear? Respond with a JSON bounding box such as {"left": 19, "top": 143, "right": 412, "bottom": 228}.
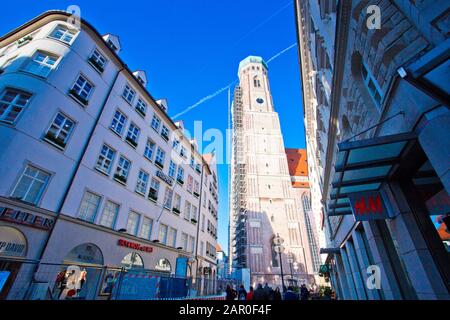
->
{"left": 0, "top": 89, "right": 31, "bottom": 123}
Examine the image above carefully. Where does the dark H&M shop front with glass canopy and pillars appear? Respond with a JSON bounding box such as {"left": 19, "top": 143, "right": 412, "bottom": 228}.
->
{"left": 323, "top": 131, "right": 450, "bottom": 299}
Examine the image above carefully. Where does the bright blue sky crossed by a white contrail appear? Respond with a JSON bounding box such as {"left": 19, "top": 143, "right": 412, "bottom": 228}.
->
{"left": 0, "top": 0, "right": 305, "bottom": 255}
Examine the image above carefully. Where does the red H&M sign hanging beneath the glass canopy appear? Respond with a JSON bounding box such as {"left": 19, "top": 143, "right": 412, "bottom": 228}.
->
{"left": 348, "top": 191, "right": 389, "bottom": 221}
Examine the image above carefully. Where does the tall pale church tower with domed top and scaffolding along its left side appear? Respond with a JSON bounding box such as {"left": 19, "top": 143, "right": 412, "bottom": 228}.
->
{"left": 230, "top": 56, "right": 314, "bottom": 286}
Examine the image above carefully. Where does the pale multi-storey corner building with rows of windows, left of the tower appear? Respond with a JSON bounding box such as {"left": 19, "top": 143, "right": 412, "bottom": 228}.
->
{"left": 0, "top": 11, "right": 218, "bottom": 299}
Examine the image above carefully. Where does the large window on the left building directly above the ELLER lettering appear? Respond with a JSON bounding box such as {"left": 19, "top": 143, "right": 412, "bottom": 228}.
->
{"left": 11, "top": 165, "right": 50, "bottom": 205}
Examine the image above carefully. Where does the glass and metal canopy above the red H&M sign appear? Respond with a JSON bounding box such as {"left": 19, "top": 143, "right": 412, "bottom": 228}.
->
{"left": 327, "top": 133, "right": 417, "bottom": 216}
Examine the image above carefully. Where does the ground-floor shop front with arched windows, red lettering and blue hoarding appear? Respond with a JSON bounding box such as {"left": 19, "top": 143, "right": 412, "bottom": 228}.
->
{"left": 28, "top": 215, "right": 193, "bottom": 300}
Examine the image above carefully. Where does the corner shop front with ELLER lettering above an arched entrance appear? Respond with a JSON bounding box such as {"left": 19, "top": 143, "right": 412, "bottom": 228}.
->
{"left": 0, "top": 198, "right": 54, "bottom": 300}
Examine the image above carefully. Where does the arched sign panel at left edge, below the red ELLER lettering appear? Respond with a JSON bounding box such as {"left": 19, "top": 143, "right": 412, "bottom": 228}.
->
{"left": 0, "top": 226, "right": 27, "bottom": 257}
